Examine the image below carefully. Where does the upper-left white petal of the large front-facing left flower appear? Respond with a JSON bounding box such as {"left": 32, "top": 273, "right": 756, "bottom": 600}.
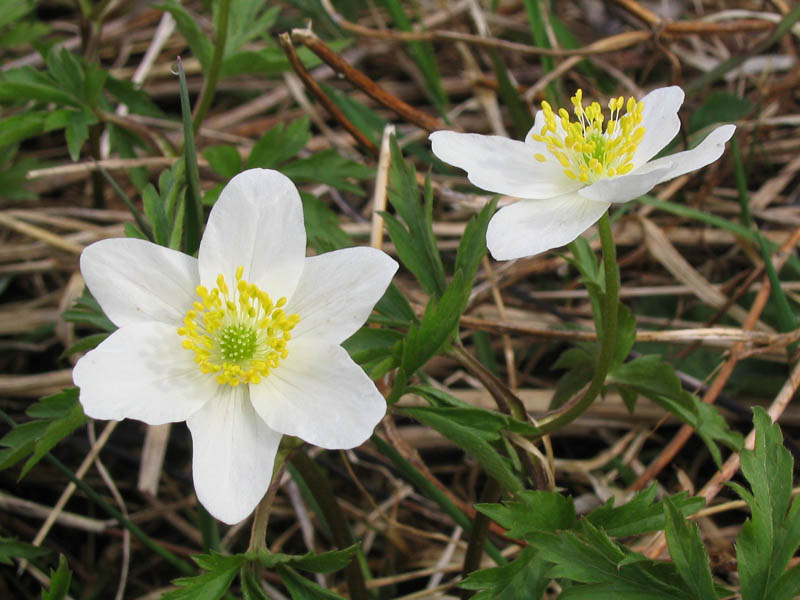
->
{"left": 81, "top": 238, "right": 199, "bottom": 327}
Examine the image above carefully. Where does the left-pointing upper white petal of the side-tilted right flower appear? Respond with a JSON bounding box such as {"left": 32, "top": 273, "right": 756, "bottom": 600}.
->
{"left": 430, "top": 131, "right": 580, "bottom": 198}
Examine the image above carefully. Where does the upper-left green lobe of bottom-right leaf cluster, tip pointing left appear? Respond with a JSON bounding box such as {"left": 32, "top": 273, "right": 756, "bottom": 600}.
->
{"left": 475, "top": 490, "right": 576, "bottom": 540}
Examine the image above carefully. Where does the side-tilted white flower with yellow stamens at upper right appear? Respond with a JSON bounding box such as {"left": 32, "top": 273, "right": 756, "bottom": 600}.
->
{"left": 430, "top": 87, "right": 736, "bottom": 260}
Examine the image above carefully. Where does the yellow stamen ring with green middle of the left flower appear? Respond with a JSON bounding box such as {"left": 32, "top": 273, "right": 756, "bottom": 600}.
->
{"left": 178, "top": 266, "right": 300, "bottom": 387}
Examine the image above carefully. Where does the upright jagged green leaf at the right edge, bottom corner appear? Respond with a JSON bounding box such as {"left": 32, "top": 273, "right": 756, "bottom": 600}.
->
{"left": 728, "top": 407, "right": 800, "bottom": 600}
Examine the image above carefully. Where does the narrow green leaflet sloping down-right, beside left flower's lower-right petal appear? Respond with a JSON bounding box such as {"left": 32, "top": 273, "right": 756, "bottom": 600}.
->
{"left": 402, "top": 407, "right": 523, "bottom": 492}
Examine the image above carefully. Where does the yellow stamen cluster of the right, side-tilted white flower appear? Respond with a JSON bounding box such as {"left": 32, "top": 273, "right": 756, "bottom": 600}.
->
{"left": 531, "top": 90, "right": 644, "bottom": 183}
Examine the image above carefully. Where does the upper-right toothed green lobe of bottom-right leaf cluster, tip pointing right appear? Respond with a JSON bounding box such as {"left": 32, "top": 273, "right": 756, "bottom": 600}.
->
{"left": 584, "top": 483, "right": 705, "bottom": 537}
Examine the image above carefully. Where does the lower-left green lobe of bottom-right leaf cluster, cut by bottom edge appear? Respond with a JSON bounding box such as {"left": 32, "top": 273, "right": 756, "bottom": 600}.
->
{"left": 459, "top": 547, "right": 550, "bottom": 600}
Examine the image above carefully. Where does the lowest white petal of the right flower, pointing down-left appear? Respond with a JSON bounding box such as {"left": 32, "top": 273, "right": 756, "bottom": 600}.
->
{"left": 486, "top": 193, "right": 610, "bottom": 260}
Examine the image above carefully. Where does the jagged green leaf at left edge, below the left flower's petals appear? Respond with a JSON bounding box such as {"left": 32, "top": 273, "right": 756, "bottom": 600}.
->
{"left": 0, "top": 388, "right": 89, "bottom": 479}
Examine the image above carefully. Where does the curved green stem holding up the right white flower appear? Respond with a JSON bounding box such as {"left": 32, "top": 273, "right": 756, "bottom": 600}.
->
{"left": 539, "top": 213, "right": 619, "bottom": 435}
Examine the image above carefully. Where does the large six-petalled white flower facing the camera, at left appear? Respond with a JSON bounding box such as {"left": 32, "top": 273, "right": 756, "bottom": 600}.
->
{"left": 73, "top": 169, "right": 397, "bottom": 523}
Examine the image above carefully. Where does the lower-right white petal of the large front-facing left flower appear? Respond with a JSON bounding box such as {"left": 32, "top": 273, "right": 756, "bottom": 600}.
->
{"left": 250, "top": 339, "right": 386, "bottom": 449}
